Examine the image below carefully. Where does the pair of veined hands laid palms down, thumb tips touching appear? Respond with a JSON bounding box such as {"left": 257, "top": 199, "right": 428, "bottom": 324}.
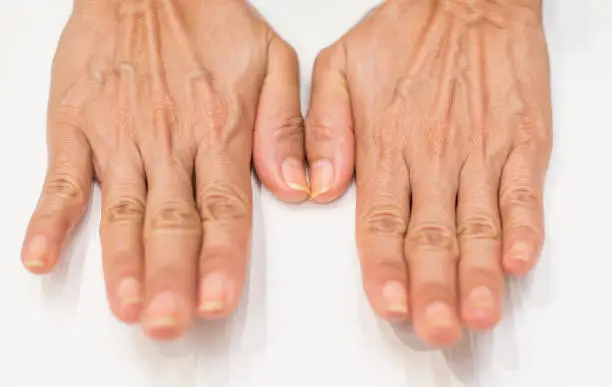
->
{"left": 22, "top": 0, "right": 551, "bottom": 346}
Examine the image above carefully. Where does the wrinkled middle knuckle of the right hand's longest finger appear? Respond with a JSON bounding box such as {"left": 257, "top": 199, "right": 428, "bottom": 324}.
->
{"left": 406, "top": 223, "right": 458, "bottom": 257}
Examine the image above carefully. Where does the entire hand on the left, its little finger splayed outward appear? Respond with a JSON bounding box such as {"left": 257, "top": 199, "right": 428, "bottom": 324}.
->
{"left": 22, "top": 0, "right": 308, "bottom": 339}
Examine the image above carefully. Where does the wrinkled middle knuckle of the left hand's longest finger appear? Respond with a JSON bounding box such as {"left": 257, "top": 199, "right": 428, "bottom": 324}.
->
{"left": 150, "top": 200, "right": 201, "bottom": 234}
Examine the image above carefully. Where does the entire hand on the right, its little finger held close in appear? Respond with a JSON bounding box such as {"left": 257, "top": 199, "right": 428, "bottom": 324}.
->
{"left": 306, "top": 0, "right": 552, "bottom": 346}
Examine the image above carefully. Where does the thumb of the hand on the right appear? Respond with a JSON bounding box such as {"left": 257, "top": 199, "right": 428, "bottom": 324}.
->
{"left": 306, "top": 46, "right": 355, "bottom": 203}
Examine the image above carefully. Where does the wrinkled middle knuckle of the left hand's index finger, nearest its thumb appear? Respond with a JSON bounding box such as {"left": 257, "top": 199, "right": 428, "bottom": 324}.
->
{"left": 197, "top": 184, "right": 250, "bottom": 222}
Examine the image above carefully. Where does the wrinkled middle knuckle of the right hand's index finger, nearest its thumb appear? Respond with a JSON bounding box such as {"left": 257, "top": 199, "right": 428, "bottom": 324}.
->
{"left": 361, "top": 203, "right": 408, "bottom": 238}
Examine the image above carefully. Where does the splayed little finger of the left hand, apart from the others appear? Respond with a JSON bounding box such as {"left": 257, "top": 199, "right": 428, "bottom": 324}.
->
{"left": 21, "top": 125, "right": 93, "bottom": 274}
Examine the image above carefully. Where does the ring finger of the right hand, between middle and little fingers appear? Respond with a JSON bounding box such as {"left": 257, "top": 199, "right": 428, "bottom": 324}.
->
{"left": 457, "top": 159, "right": 504, "bottom": 329}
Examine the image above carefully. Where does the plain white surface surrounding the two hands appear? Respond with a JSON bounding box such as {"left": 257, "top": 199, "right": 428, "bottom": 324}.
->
{"left": 0, "top": 0, "right": 612, "bottom": 387}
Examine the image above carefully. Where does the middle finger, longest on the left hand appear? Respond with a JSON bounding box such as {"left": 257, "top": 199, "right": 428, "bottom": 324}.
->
{"left": 143, "top": 157, "right": 202, "bottom": 339}
